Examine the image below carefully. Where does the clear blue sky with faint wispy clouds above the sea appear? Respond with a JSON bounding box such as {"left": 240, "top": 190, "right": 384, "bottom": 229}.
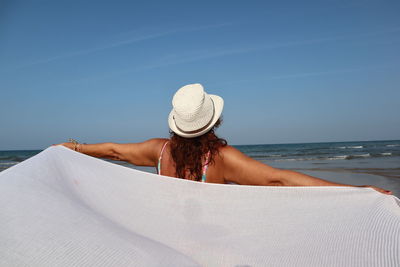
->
{"left": 0, "top": 1, "right": 400, "bottom": 150}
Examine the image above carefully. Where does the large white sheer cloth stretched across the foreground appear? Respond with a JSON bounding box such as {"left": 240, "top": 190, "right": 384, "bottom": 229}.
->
{"left": 0, "top": 146, "right": 400, "bottom": 266}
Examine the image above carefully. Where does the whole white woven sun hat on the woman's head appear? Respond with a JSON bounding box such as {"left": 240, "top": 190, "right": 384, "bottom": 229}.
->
{"left": 168, "top": 83, "right": 224, "bottom": 138}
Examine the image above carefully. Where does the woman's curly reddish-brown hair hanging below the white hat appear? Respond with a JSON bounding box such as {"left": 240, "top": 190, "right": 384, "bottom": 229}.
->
{"left": 170, "top": 118, "right": 228, "bottom": 181}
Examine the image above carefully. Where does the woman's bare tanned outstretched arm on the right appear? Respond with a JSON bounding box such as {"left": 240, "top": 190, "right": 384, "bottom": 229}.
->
{"left": 222, "top": 146, "right": 391, "bottom": 194}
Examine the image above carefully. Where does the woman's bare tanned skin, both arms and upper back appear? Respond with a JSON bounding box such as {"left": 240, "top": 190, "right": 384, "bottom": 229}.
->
{"left": 54, "top": 138, "right": 392, "bottom": 195}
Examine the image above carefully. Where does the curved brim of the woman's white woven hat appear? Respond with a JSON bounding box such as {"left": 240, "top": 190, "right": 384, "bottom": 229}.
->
{"left": 168, "top": 94, "right": 224, "bottom": 138}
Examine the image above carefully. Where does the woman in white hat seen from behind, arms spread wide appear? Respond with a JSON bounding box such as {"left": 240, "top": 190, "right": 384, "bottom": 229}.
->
{"left": 55, "top": 84, "right": 392, "bottom": 194}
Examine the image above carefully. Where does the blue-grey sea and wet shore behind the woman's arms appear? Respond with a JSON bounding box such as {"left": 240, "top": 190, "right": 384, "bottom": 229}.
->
{"left": 0, "top": 140, "right": 400, "bottom": 196}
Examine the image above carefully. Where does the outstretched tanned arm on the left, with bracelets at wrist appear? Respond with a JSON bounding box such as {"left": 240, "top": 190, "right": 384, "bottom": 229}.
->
{"left": 54, "top": 139, "right": 165, "bottom": 166}
